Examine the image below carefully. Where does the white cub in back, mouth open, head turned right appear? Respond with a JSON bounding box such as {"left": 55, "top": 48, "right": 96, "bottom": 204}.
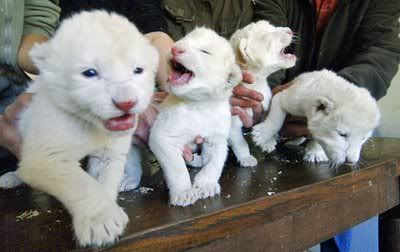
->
{"left": 229, "top": 21, "right": 296, "bottom": 166}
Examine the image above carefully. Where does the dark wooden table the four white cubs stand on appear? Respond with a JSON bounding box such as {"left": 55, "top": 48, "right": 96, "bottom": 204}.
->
{"left": 0, "top": 138, "right": 400, "bottom": 251}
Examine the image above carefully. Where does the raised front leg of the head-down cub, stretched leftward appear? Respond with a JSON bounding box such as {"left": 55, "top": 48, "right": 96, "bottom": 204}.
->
{"left": 251, "top": 92, "right": 287, "bottom": 153}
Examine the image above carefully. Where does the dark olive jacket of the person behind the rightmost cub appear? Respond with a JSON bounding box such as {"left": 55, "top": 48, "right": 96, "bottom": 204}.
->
{"left": 254, "top": 0, "right": 400, "bottom": 99}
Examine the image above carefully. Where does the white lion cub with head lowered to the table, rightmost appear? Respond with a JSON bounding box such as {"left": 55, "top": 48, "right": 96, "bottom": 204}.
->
{"left": 252, "top": 70, "right": 380, "bottom": 166}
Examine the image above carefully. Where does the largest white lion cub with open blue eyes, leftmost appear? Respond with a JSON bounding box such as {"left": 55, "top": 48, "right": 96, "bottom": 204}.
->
{"left": 0, "top": 11, "right": 158, "bottom": 246}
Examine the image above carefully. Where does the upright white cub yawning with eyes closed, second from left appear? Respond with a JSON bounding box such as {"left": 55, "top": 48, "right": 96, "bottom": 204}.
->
{"left": 149, "top": 28, "right": 242, "bottom": 206}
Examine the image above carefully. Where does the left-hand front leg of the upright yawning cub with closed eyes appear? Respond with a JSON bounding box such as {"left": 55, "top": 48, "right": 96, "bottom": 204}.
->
{"left": 149, "top": 136, "right": 196, "bottom": 206}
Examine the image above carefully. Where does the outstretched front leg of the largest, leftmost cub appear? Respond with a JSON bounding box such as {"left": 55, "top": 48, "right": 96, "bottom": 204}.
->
{"left": 18, "top": 151, "right": 128, "bottom": 246}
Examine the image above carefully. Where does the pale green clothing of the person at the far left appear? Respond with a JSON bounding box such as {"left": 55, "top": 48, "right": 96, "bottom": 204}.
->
{"left": 0, "top": 0, "right": 61, "bottom": 113}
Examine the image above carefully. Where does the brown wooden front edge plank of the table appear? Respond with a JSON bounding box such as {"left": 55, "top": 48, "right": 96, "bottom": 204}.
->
{"left": 111, "top": 160, "right": 399, "bottom": 251}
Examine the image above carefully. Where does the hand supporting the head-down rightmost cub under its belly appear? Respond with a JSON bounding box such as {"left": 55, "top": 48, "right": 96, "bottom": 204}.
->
{"left": 272, "top": 82, "right": 310, "bottom": 138}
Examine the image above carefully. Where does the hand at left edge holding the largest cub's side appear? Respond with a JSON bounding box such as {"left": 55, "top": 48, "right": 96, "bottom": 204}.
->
{"left": 0, "top": 93, "right": 32, "bottom": 159}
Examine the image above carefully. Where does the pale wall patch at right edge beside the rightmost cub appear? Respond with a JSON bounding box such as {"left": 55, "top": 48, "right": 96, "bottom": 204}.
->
{"left": 375, "top": 65, "right": 400, "bottom": 138}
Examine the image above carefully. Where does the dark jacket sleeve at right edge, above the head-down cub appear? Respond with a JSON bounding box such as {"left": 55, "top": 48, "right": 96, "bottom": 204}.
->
{"left": 337, "top": 0, "right": 400, "bottom": 99}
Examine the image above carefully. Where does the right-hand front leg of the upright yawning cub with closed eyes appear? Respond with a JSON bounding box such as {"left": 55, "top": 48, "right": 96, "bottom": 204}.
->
{"left": 193, "top": 137, "right": 228, "bottom": 199}
